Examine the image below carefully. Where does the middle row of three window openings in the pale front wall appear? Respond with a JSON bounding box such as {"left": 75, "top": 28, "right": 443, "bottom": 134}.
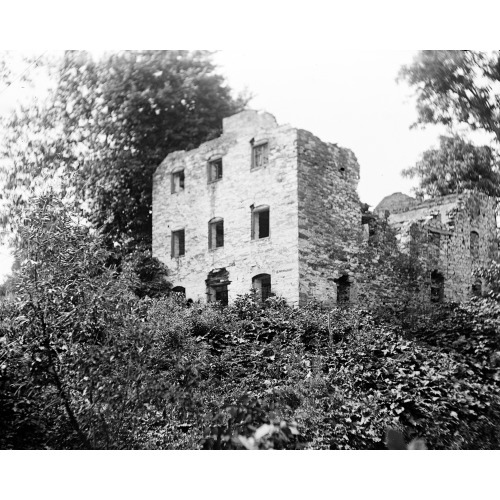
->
{"left": 172, "top": 205, "right": 270, "bottom": 257}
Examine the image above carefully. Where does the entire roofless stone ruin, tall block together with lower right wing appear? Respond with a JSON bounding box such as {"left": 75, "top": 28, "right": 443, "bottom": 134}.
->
{"left": 153, "top": 110, "right": 497, "bottom": 306}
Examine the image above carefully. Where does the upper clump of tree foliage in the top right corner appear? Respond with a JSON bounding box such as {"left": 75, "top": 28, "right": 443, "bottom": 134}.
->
{"left": 400, "top": 50, "right": 500, "bottom": 142}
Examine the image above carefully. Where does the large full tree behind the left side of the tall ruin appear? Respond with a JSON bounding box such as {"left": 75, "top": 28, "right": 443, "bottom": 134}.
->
{"left": 0, "top": 51, "right": 246, "bottom": 250}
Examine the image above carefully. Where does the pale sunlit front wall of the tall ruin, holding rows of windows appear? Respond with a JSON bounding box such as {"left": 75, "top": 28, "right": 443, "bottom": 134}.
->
{"left": 153, "top": 111, "right": 299, "bottom": 304}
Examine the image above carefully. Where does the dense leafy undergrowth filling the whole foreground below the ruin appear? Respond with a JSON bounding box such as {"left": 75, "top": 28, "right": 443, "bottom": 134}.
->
{"left": 0, "top": 197, "right": 500, "bottom": 449}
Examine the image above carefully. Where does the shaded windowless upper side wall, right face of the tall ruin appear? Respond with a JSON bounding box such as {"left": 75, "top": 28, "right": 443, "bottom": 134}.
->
{"left": 298, "top": 130, "right": 361, "bottom": 305}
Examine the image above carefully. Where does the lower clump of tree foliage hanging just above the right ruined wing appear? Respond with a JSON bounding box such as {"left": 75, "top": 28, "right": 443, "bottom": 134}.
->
{"left": 403, "top": 136, "right": 500, "bottom": 197}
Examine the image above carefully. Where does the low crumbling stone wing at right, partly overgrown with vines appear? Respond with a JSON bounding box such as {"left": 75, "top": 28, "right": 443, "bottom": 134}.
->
{"left": 375, "top": 192, "right": 498, "bottom": 302}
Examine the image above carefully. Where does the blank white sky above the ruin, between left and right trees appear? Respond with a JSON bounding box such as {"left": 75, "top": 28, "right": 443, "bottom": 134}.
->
{"left": 216, "top": 50, "right": 454, "bottom": 206}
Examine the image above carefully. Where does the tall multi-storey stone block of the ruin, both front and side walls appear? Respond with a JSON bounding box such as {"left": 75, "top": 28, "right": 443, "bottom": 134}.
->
{"left": 153, "top": 111, "right": 361, "bottom": 305}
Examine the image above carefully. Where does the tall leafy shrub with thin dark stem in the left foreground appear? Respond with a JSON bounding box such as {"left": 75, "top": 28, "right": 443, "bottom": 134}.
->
{"left": 2, "top": 197, "right": 201, "bottom": 448}
